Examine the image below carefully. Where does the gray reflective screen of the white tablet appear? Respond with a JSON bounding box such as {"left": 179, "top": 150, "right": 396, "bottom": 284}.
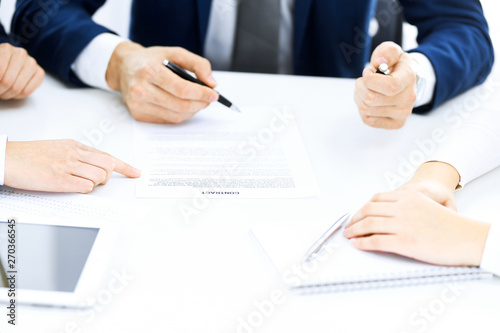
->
{"left": 0, "top": 222, "right": 99, "bottom": 292}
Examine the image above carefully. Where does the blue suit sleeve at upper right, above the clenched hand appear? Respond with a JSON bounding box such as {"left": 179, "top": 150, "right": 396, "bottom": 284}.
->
{"left": 401, "top": 0, "right": 494, "bottom": 113}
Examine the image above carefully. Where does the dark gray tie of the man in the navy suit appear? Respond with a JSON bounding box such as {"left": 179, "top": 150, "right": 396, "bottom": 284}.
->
{"left": 232, "top": 0, "right": 281, "bottom": 73}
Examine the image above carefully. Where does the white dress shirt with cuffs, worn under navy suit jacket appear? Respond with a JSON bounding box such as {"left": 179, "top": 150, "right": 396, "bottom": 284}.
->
{"left": 72, "top": 0, "right": 436, "bottom": 107}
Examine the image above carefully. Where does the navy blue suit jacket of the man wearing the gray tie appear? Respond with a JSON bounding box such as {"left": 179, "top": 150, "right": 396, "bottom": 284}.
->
{"left": 12, "top": 0, "right": 493, "bottom": 111}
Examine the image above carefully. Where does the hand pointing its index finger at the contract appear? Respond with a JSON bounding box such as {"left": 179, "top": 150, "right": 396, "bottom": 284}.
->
{"left": 5, "top": 140, "right": 140, "bottom": 193}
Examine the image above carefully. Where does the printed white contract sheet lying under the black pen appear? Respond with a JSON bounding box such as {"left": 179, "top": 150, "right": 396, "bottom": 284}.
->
{"left": 134, "top": 105, "right": 319, "bottom": 198}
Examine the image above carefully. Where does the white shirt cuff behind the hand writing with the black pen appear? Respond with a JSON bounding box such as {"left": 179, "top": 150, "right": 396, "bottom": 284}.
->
{"left": 71, "top": 33, "right": 128, "bottom": 91}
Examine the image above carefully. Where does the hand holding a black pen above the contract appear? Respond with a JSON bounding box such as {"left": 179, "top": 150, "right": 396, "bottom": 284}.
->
{"left": 106, "top": 42, "right": 219, "bottom": 123}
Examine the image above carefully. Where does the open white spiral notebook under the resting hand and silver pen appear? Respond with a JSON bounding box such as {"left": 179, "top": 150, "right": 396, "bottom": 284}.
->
{"left": 252, "top": 220, "right": 493, "bottom": 293}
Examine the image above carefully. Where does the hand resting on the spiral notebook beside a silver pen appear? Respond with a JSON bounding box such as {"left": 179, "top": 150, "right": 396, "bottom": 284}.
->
{"left": 344, "top": 190, "right": 490, "bottom": 266}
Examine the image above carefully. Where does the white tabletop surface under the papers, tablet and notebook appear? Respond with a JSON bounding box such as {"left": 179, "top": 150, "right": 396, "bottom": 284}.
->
{"left": 0, "top": 72, "right": 500, "bottom": 333}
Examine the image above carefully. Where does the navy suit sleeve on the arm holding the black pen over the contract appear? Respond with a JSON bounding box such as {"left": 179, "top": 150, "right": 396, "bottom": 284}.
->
{"left": 11, "top": 0, "right": 111, "bottom": 86}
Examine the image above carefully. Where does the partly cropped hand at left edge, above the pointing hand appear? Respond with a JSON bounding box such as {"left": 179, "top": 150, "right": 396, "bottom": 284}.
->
{"left": 0, "top": 43, "right": 45, "bottom": 100}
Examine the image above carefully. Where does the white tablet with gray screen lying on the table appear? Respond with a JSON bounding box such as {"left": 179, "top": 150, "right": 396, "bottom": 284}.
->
{"left": 0, "top": 219, "right": 119, "bottom": 308}
